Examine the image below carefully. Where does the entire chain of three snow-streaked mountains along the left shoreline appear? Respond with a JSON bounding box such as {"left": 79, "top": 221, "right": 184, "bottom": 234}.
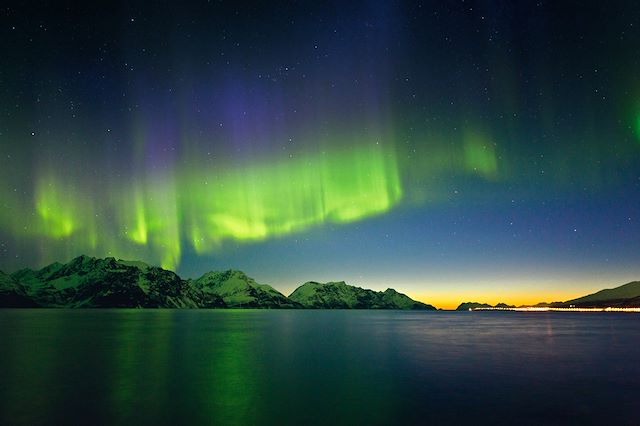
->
{"left": 0, "top": 256, "right": 436, "bottom": 310}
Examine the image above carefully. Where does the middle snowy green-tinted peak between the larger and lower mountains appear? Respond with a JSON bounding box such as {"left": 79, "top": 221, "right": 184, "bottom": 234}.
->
{"left": 193, "top": 269, "right": 301, "bottom": 308}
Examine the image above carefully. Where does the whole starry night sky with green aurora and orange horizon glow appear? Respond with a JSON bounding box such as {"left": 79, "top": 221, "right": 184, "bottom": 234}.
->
{"left": 0, "top": 0, "right": 640, "bottom": 307}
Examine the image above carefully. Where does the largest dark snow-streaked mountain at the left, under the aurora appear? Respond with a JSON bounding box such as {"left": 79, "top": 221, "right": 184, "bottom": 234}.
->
{"left": 12, "top": 256, "right": 226, "bottom": 308}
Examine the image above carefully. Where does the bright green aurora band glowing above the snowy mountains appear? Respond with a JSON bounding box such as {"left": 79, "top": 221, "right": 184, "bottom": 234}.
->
{"left": 2, "top": 137, "right": 402, "bottom": 269}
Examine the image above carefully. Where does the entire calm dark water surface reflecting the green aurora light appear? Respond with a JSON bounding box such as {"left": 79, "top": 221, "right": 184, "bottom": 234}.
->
{"left": 0, "top": 310, "right": 640, "bottom": 425}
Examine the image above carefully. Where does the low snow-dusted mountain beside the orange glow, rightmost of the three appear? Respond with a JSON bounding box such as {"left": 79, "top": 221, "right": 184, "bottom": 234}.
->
{"left": 289, "top": 281, "right": 436, "bottom": 310}
